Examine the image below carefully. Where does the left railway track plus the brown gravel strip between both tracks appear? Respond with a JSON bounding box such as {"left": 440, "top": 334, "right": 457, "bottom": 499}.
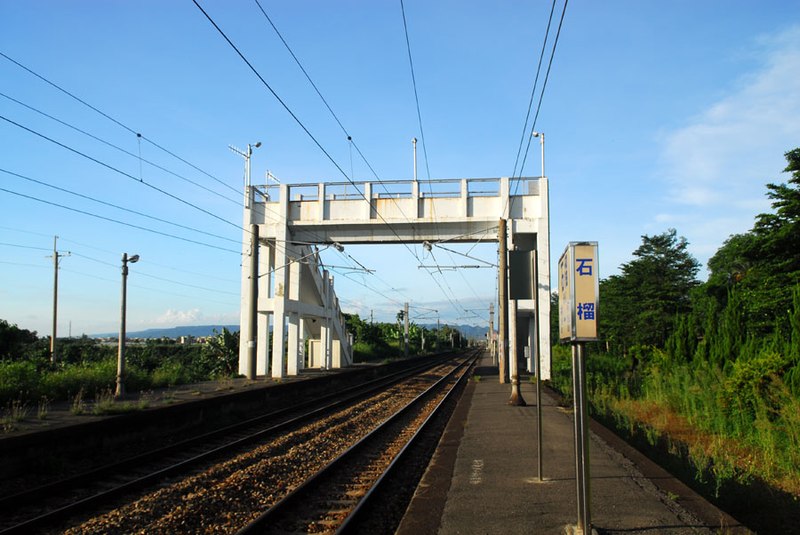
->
{"left": 0, "top": 352, "right": 476, "bottom": 533}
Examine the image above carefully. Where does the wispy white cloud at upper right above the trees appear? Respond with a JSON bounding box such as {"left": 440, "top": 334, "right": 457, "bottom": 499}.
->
{"left": 660, "top": 26, "right": 800, "bottom": 209}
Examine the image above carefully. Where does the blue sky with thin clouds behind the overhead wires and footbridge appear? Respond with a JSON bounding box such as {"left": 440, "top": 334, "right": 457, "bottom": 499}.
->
{"left": 0, "top": 0, "right": 800, "bottom": 335}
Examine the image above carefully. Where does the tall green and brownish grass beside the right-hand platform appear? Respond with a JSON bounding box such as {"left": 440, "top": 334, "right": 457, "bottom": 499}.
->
{"left": 552, "top": 344, "right": 800, "bottom": 495}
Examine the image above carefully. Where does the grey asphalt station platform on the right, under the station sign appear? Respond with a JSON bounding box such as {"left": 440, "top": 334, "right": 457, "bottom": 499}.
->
{"left": 397, "top": 355, "right": 750, "bottom": 535}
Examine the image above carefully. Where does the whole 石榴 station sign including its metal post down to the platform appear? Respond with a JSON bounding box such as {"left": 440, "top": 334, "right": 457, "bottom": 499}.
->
{"left": 558, "top": 242, "right": 599, "bottom": 533}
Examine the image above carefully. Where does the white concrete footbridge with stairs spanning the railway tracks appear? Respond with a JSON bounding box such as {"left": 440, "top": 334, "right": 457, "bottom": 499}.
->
{"left": 239, "top": 177, "right": 550, "bottom": 379}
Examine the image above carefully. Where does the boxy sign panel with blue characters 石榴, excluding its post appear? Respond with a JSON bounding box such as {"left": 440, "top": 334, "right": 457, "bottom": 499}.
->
{"left": 558, "top": 242, "right": 600, "bottom": 342}
